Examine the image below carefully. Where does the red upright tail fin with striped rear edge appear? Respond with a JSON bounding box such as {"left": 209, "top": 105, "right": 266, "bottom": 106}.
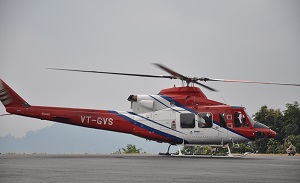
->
{"left": 0, "top": 79, "right": 30, "bottom": 108}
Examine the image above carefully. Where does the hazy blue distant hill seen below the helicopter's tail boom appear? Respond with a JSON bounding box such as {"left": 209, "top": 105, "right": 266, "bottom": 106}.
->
{"left": 0, "top": 123, "right": 176, "bottom": 154}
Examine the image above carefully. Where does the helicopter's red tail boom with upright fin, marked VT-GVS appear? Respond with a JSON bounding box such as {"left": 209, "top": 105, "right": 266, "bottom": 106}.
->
{"left": 0, "top": 80, "right": 181, "bottom": 143}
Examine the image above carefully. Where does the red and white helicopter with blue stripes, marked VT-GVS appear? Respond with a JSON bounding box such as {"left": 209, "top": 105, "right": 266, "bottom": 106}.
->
{"left": 0, "top": 64, "right": 300, "bottom": 156}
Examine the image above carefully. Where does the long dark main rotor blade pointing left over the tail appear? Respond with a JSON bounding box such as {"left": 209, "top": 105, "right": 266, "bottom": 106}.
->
{"left": 46, "top": 68, "right": 176, "bottom": 79}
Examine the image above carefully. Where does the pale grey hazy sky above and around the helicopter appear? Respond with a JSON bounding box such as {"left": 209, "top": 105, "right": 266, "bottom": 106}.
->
{"left": 0, "top": 0, "right": 300, "bottom": 140}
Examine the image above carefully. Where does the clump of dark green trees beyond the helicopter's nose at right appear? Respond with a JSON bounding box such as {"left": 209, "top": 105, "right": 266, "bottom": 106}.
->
{"left": 253, "top": 102, "right": 300, "bottom": 153}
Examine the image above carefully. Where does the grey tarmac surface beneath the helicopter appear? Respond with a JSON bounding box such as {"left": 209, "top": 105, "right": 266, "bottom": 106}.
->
{"left": 0, "top": 154, "right": 300, "bottom": 183}
